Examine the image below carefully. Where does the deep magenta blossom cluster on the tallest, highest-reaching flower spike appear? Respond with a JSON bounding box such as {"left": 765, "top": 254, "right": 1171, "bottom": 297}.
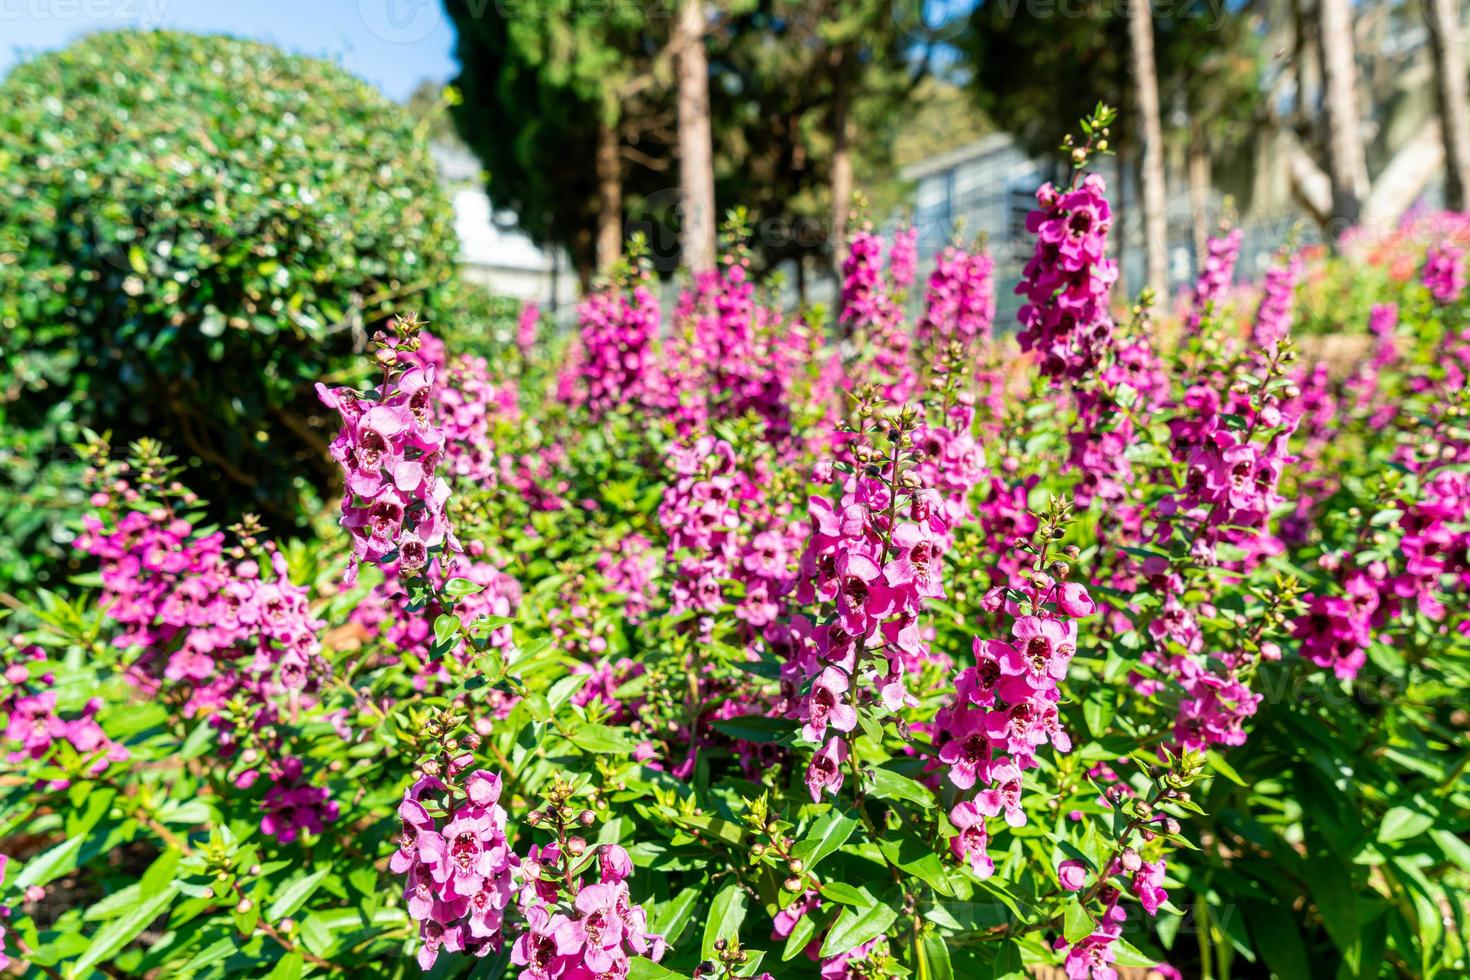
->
{"left": 1016, "top": 173, "right": 1117, "bottom": 379}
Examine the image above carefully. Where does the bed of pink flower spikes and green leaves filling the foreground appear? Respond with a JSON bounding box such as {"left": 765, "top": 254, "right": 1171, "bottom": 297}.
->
{"left": 0, "top": 128, "right": 1470, "bottom": 980}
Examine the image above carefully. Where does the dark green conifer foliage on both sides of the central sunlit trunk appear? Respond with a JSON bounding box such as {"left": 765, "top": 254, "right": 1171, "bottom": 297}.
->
{"left": 447, "top": 0, "right": 926, "bottom": 278}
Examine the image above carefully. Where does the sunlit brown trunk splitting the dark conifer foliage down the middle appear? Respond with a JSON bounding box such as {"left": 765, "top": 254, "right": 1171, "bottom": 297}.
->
{"left": 675, "top": 0, "right": 714, "bottom": 272}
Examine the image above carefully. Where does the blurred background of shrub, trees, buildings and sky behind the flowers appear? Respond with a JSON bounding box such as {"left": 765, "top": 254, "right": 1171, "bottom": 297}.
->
{"left": 0, "top": 0, "right": 1452, "bottom": 588}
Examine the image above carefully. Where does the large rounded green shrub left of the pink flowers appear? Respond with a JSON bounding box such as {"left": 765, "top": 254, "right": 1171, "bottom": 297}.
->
{"left": 0, "top": 31, "right": 457, "bottom": 586}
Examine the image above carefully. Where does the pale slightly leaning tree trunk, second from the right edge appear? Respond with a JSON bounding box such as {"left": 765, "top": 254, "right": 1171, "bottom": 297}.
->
{"left": 1317, "top": 0, "right": 1369, "bottom": 224}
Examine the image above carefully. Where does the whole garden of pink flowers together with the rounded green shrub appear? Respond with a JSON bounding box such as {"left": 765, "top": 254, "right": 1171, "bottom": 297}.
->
{"left": 0, "top": 21, "right": 1470, "bottom": 980}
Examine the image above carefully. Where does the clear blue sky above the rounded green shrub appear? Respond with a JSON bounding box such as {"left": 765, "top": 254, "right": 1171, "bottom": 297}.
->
{"left": 0, "top": 0, "right": 456, "bottom": 101}
